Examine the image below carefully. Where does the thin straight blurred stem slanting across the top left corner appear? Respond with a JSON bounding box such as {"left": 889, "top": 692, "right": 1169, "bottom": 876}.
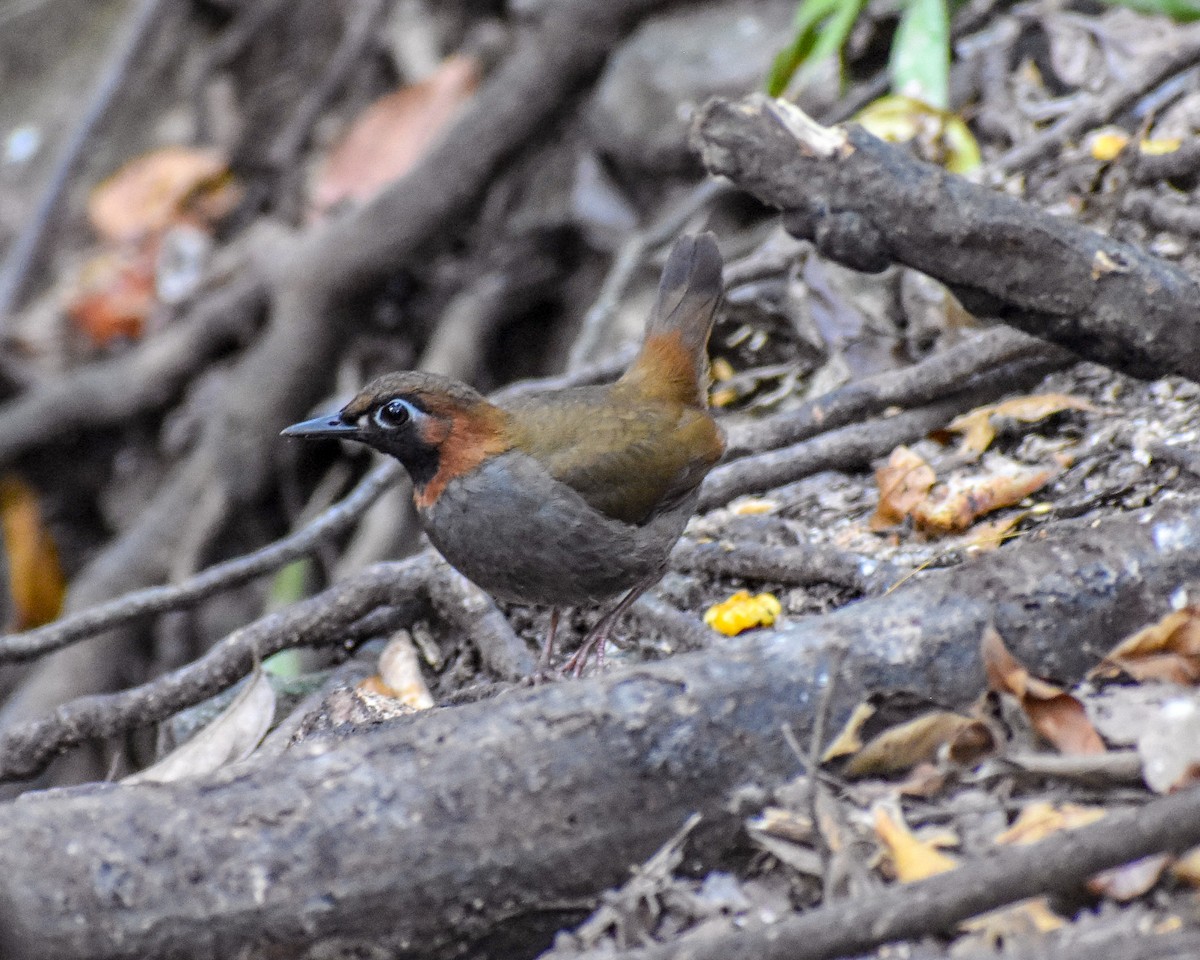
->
{"left": 0, "top": 0, "right": 174, "bottom": 328}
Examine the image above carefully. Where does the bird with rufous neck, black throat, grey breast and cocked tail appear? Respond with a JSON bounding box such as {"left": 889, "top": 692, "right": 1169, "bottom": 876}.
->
{"left": 283, "top": 233, "right": 725, "bottom": 677}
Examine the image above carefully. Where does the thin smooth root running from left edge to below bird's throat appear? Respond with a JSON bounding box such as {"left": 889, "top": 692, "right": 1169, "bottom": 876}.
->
{"left": 0, "top": 461, "right": 401, "bottom": 661}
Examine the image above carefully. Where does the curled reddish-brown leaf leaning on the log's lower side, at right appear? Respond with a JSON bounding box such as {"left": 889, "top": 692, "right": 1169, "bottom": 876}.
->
{"left": 980, "top": 626, "right": 1108, "bottom": 754}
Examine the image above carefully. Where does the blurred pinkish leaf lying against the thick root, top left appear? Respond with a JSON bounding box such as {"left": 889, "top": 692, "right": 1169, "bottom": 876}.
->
{"left": 312, "top": 55, "right": 480, "bottom": 214}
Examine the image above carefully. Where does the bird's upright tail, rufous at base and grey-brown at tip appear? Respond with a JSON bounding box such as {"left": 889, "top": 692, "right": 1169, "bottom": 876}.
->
{"left": 622, "top": 233, "right": 722, "bottom": 407}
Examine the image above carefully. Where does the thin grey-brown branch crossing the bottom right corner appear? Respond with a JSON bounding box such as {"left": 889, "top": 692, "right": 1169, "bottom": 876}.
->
{"left": 607, "top": 788, "right": 1200, "bottom": 960}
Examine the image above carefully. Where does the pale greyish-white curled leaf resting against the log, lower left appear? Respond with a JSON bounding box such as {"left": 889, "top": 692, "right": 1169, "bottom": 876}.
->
{"left": 121, "top": 670, "right": 275, "bottom": 784}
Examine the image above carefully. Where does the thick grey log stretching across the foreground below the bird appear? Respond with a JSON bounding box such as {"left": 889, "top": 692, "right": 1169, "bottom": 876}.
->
{"left": 0, "top": 503, "right": 1200, "bottom": 958}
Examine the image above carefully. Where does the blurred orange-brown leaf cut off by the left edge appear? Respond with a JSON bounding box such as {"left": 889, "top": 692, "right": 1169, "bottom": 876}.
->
{"left": 0, "top": 474, "right": 66, "bottom": 630}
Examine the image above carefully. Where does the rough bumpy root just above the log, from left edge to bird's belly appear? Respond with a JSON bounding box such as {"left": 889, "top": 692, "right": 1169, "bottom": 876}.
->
{"left": 0, "top": 554, "right": 433, "bottom": 780}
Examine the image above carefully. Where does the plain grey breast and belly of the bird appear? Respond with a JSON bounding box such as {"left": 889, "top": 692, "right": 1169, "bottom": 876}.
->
{"left": 421, "top": 451, "right": 697, "bottom": 606}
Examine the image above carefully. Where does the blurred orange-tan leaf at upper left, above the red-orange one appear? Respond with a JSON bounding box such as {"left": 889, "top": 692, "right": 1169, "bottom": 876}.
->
{"left": 88, "top": 146, "right": 230, "bottom": 244}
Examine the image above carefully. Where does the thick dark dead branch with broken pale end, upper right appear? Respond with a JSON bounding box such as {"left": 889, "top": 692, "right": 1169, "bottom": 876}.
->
{"left": 692, "top": 95, "right": 1200, "bottom": 379}
